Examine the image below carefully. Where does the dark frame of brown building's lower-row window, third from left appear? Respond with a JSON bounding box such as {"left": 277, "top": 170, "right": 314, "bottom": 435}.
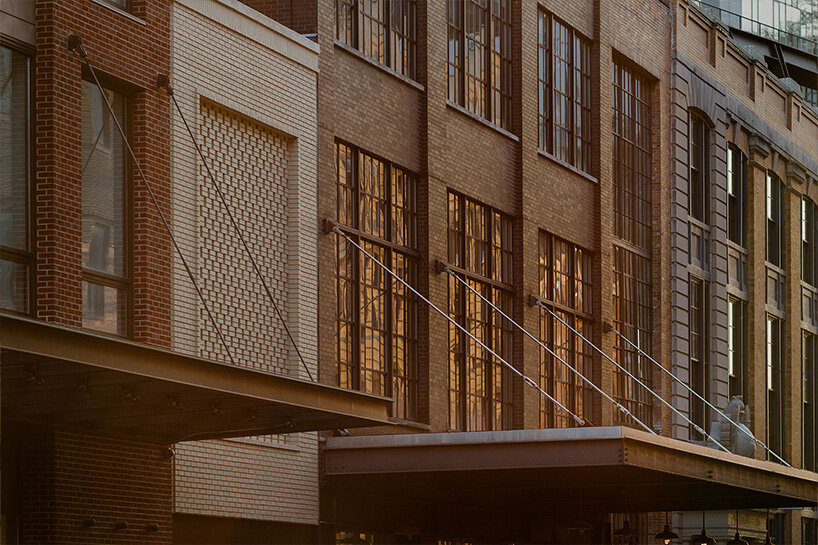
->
{"left": 535, "top": 230, "right": 594, "bottom": 428}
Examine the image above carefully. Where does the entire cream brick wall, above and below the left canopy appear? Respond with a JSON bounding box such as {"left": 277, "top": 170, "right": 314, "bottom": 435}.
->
{"left": 171, "top": 0, "right": 318, "bottom": 524}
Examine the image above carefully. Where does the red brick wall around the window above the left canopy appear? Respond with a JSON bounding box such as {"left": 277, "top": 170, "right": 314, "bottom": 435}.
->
{"left": 34, "top": 0, "right": 170, "bottom": 346}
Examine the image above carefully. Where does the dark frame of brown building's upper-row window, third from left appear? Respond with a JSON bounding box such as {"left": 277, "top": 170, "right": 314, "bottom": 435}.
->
{"left": 537, "top": 8, "right": 593, "bottom": 174}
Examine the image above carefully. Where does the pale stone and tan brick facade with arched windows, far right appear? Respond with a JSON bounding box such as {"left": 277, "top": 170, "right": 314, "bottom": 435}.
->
{"left": 670, "top": 1, "right": 818, "bottom": 543}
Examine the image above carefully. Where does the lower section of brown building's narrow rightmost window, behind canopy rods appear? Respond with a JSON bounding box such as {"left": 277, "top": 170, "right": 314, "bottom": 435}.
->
{"left": 613, "top": 245, "right": 653, "bottom": 425}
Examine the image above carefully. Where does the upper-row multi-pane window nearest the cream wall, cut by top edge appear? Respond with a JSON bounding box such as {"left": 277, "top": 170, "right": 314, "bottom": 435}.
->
{"left": 335, "top": 0, "right": 417, "bottom": 78}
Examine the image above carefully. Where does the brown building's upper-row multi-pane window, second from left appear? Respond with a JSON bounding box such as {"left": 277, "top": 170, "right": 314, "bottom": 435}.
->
{"left": 446, "top": 0, "right": 511, "bottom": 129}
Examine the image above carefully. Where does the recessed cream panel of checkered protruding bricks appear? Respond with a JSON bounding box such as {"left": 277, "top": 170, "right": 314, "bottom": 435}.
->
{"left": 199, "top": 104, "right": 289, "bottom": 374}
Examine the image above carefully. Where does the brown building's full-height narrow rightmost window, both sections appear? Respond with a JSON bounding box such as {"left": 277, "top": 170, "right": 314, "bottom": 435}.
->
{"left": 612, "top": 59, "right": 653, "bottom": 423}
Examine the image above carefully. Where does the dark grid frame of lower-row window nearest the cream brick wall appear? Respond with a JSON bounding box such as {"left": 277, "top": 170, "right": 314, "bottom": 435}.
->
{"left": 334, "top": 139, "right": 421, "bottom": 421}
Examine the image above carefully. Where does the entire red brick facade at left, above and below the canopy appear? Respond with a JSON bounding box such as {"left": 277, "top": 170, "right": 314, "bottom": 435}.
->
{"left": 2, "top": 0, "right": 172, "bottom": 544}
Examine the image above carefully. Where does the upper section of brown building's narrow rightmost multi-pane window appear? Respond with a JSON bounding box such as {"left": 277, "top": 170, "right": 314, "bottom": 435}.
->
{"left": 613, "top": 61, "right": 652, "bottom": 251}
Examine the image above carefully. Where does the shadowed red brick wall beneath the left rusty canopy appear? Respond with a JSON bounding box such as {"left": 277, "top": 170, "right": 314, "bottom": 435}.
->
{"left": 18, "top": 430, "right": 172, "bottom": 545}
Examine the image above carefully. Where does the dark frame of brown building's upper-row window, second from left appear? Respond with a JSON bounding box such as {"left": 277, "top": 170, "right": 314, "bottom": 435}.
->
{"left": 446, "top": 0, "right": 514, "bottom": 130}
